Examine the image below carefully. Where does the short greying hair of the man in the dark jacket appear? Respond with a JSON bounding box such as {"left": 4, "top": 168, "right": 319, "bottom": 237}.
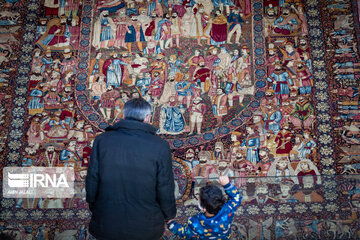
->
{"left": 124, "top": 97, "right": 152, "bottom": 121}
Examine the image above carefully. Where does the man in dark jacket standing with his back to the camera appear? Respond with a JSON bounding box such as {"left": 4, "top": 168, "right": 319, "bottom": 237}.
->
{"left": 86, "top": 98, "right": 176, "bottom": 240}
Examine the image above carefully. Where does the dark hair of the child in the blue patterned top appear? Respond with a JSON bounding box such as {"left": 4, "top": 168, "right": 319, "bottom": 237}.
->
{"left": 200, "top": 184, "right": 225, "bottom": 215}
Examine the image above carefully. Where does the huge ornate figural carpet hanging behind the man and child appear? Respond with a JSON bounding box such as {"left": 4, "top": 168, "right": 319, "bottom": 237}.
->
{"left": 0, "top": 0, "right": 360, "bottom": 240}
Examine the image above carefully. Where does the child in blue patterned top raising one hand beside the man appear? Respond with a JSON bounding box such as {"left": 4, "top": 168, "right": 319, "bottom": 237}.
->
{"left": 168, "top": 176, "right": 241, "bottom": 239}
